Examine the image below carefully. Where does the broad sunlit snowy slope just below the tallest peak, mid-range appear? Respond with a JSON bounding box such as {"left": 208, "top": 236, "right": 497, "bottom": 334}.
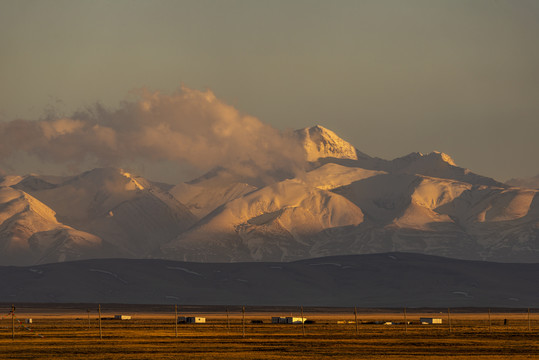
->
{"left": 164, "top": 179, "right": 363, "bottom": 261}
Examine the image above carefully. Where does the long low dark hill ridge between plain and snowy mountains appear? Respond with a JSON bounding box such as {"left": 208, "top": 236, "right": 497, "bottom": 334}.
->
{"left": 0, "top": 253, "right": 539, "bottom": 307}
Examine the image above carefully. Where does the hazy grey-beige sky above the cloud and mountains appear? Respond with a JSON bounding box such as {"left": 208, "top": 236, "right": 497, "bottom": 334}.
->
{"left": 0, "top": 0, "right": 539, "bottom": 180}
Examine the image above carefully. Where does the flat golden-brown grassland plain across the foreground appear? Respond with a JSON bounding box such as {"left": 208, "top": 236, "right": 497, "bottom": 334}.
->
{"left": 0, "top": 304, "right": 539, "bottom": 360}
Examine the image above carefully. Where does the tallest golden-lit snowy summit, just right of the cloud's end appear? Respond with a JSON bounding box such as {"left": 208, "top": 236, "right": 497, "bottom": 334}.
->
{"left": 296, "top": 125, "right": 368, "bottom": 161}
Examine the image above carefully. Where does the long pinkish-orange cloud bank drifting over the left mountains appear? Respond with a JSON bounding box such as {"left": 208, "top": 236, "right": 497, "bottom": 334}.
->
{"left": 0, "top": 87, "right": 306, "bottom": 183}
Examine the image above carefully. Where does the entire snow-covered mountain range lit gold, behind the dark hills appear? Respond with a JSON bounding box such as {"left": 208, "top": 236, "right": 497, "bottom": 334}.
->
{"left": 0, "top": 126, "right": 539, "bottom": 265}
